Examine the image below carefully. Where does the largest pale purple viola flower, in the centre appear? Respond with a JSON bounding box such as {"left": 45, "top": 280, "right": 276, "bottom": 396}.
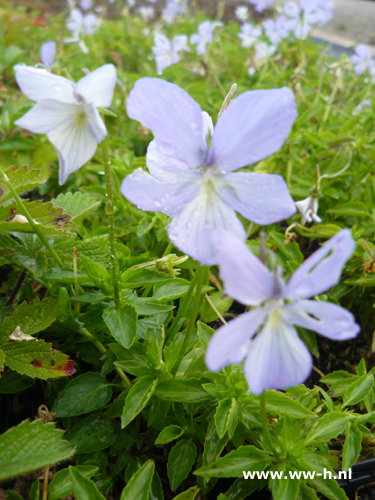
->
{"left": 121, "top": 78, "right": 297, "bottom": 265}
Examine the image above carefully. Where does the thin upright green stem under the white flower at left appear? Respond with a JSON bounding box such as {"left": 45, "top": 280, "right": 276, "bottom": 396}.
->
{"left": 102, "top": 137, "right": 120, "bottom": 309}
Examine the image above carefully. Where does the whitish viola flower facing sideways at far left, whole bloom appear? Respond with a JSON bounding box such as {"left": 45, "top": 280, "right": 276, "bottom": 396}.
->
{"left": 14, "top": 64, "right": 117, "bottom": 185}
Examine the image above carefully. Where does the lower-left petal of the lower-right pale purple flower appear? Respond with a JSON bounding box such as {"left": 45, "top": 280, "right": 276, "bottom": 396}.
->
{"left": 205, "top": 308, "right": 268, "bottom": 372}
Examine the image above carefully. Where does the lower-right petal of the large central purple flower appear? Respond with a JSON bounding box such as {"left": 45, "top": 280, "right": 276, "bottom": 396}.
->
{"left": 217, "top": 172, "right": 296, "bottom": 226}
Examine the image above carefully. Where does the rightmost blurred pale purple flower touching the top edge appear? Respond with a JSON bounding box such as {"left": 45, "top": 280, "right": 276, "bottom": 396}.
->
{"left": 284, "top": 0, "right": 321, "bottom": 40}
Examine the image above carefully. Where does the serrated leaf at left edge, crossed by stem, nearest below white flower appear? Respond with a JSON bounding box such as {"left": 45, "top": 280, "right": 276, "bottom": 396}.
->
{"left": 0, "top": 164, "right": 48, "bottom": 205}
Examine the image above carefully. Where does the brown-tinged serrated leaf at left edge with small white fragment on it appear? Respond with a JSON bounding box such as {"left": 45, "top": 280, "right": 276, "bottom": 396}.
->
{"left": 0, "top": 200, "right": 77, "bottom": 235}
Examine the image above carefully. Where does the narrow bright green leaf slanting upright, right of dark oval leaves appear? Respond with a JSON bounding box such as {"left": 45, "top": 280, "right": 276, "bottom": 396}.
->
{"left": 121, "top": 375, "right": 158, "bottom": 428}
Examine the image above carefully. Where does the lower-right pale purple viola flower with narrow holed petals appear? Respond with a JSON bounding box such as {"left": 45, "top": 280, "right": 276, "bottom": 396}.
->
{"left": 206, "top": 229, "right": 360, "bottom": 394}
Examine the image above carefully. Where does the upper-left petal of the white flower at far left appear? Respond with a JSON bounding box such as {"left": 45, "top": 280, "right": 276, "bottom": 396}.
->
{"left": 14, "top": 64, "right": 76, "bottom": 102}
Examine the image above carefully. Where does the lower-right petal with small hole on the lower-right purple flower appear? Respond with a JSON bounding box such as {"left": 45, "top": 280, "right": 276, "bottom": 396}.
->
{"left": 283, "top": 300, "right": 361, "bottom": 340}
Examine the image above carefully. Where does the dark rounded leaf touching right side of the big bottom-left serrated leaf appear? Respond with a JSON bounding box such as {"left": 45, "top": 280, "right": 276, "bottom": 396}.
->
{"left": 65, "top": 415, "right": 116, "bottom": 453}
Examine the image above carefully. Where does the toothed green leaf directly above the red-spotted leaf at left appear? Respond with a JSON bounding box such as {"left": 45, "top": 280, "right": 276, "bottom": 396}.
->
{"left": 0, "top": 297, "right": 58, "bottom": 345}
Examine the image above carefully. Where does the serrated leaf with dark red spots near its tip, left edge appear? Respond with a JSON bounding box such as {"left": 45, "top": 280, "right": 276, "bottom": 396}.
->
{"left": 2, "top": 340, "right": 74, "bottom": 380}
